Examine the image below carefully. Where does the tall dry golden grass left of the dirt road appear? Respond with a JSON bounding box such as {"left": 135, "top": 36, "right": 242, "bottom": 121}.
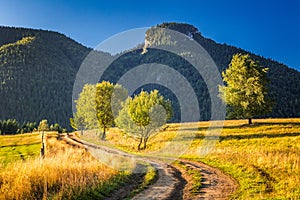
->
{"left": 0, "top": 134, "right": 130, "bottom": 200}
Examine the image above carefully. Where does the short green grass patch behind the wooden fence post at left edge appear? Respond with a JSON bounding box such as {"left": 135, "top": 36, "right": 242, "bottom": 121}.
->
{"left": 0, "top": 133, "right": 41, "bottom": 165}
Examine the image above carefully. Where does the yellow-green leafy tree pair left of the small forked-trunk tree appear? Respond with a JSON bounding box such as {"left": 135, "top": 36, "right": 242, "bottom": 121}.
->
{"left": 74, "top": 81, "right": 127, "bottom": 139}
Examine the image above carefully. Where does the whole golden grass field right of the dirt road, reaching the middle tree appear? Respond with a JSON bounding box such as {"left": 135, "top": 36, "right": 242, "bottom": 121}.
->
{"left": 84, "top": 119, "right": 300, "bottom": 199}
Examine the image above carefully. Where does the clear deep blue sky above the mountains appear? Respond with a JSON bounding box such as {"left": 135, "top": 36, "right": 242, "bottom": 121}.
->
{"left": 0, "top": 0, "right": 300, "bottom": 71}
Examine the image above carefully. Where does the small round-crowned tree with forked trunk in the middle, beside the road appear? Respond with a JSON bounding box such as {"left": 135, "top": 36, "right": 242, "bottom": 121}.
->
{"left": 116, "top": 90, "right": 172, "bottom": 150}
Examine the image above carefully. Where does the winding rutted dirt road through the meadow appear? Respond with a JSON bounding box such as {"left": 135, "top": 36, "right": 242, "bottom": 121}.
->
{"left": 66, "top": 137, "right": 237, "bottom": 200}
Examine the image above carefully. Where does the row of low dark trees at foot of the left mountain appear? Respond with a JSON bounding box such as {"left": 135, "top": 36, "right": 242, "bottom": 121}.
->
{"left": 0, "top": 119, "right": 67, "bottom": 135}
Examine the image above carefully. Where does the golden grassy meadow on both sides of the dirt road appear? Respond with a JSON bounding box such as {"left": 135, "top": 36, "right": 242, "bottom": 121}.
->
{"left": 0, "top": 119, "right": 300, "bottom": 200}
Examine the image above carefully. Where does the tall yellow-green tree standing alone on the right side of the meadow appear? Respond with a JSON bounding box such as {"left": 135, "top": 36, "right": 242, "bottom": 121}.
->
{"left": 219, "top": 54, "right": 272, "bottom": 124}
